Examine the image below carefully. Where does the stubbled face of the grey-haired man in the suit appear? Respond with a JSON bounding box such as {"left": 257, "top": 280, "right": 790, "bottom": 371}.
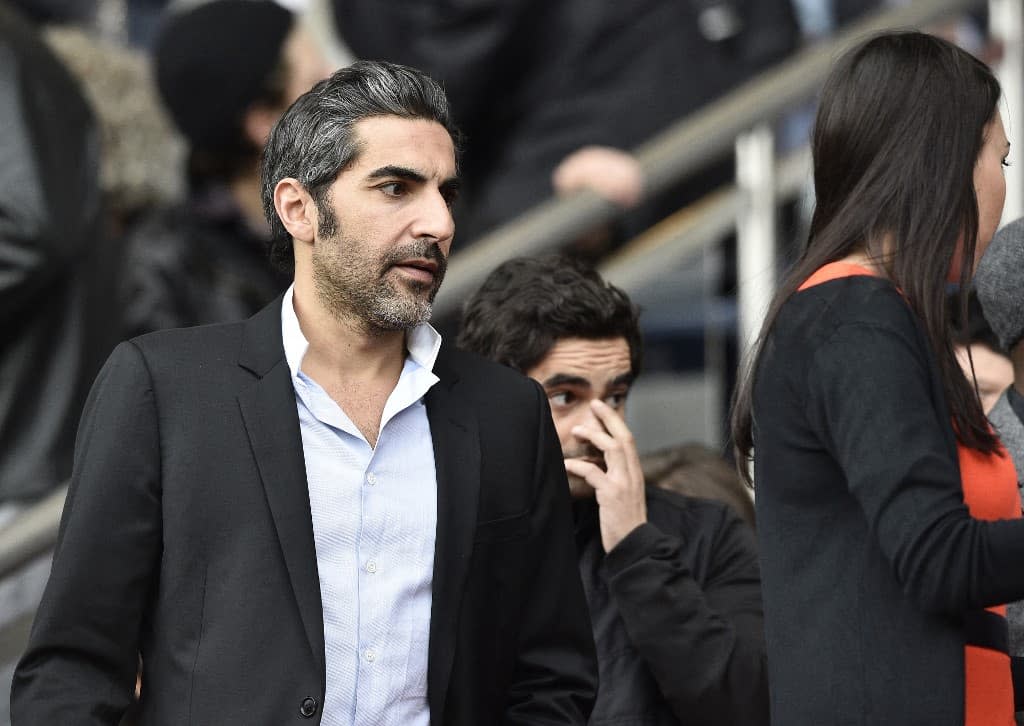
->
{"left": 307, "top": 116, "right": 458, "bottom": 331}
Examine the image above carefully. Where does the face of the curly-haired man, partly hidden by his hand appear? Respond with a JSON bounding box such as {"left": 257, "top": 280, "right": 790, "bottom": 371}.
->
{"left": 526, "top": 338, "right": 633, "bottom": 497}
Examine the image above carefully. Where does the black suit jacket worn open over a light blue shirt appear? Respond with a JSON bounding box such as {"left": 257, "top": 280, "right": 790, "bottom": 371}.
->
{"left": 11, "top": 299, "right": 596, "bottom": 726}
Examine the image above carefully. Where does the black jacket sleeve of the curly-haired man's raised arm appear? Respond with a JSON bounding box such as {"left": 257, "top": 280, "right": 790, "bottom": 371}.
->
{"left": 604, "top": 506, "right": 768, "bottom": 726}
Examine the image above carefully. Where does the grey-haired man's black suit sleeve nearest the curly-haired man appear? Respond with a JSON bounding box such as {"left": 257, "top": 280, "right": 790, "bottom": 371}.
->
{"left": 504, "top": 386, "right": 597, "bottom": 726}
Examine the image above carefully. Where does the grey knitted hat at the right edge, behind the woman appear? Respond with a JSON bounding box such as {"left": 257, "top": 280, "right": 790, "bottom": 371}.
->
{"left": 974, "top": 218, "right": 1024, "bottom": 352}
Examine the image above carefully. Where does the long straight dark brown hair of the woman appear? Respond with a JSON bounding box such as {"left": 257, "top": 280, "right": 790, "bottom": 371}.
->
{"left": 732, "top": 32, "right": 999, "bottom": 477}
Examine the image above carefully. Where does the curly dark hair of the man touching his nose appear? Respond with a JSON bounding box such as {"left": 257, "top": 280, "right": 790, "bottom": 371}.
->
{"left": 457, "top": 255, "right": 643, "bottom": 376}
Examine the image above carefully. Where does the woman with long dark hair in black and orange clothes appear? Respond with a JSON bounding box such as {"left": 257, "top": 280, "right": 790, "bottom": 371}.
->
{"left": 732, "top": 33, "right": 1024, "bottom": 726}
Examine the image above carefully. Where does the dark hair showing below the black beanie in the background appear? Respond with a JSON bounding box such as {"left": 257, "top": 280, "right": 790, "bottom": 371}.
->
{"left": 185, "top": 53, "right": 292, "bottom": 188}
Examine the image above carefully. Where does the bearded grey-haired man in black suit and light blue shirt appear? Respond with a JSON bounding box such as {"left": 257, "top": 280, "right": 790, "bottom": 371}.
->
{"left": 12, "top": 62, "right": 596, "bottom": 726}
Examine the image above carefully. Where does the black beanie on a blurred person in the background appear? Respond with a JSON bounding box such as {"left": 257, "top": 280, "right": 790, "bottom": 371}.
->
{"left": 154, "top": 0, "right": 295, "bottom": 150}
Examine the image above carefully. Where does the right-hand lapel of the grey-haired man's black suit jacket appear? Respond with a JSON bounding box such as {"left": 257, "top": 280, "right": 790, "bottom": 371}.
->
{"left": 426, "top": 348, "right": 480, "bottom": 723}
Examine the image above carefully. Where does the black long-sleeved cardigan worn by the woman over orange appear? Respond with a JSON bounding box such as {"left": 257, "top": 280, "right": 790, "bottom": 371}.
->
{"left": 754, "top": 276, "right": 1024, "bottom": 726}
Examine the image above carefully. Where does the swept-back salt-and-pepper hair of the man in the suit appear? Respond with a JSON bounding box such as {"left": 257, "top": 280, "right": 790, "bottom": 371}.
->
{"left": 261, "top": 60, "right": 461, "bottom": 269}
